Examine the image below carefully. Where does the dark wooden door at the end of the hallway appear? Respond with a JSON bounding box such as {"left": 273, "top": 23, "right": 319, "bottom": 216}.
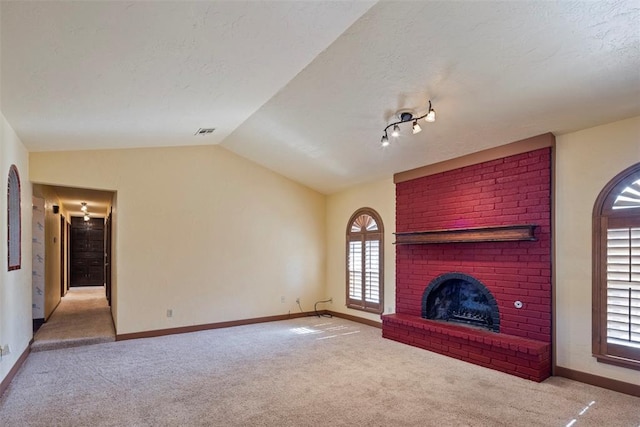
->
{"left": 71, "top": 217, "right": 104, "bottom": 286}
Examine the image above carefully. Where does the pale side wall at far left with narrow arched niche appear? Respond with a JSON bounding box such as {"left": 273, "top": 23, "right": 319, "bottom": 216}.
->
{"left": 0, "top": 113, "right": 33, "bottom": 380}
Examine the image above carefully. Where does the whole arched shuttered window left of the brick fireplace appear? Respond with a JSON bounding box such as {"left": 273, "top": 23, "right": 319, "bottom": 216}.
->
{"left": 347, "top": 208, "right": 384, "bottom": 313}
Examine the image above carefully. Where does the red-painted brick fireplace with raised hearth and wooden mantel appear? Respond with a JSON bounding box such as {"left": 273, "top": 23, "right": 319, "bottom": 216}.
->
{"left": 382, "top": 139, "right": 553, "bottom": 381}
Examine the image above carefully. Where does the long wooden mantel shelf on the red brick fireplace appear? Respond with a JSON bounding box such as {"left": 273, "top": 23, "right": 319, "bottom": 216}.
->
{"left": 394, "top": 224, "right": 537, "bottom": 245}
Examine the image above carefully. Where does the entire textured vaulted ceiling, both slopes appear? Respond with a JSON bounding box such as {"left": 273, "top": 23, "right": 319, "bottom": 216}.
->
{"left": 0, "top": 0, "right": 640, "bottom": 193}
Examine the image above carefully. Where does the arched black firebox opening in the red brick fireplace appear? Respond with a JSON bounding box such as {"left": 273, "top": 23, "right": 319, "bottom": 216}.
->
{"left": 422, "top": 273, "right": 500, "bottom": 332}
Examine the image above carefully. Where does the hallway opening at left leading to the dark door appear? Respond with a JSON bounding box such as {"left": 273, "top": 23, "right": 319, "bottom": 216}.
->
{"left": 33, "top": 184, "right": 116, "bottom": 343}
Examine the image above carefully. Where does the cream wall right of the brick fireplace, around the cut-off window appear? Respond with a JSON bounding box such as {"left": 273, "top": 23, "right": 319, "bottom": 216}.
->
{"left": 555, "top": 117, "right": 640, "bottom": 384}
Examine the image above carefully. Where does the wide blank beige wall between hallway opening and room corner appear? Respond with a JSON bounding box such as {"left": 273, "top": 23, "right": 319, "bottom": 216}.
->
{"left": 30, "top": 146, "right": 325, "bottom": 334}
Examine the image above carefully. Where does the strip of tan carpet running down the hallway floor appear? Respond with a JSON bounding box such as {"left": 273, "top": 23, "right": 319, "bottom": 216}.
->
{"left": 31, "top": 286, "right": 116, "bottom": 352}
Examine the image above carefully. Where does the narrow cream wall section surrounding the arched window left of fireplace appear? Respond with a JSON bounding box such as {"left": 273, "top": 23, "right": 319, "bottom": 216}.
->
{"left": 325, "top": 177, "right": 396, "bottom": 322}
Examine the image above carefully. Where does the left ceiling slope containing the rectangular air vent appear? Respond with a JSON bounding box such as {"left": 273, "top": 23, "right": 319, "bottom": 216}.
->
{"left": 0, "top": 1, "right": 373, "bottom": 151}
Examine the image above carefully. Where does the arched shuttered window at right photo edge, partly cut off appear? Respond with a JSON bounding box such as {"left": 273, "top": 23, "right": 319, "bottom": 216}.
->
{"left": 592, "top": 163, "right": 640, "bottom": 369}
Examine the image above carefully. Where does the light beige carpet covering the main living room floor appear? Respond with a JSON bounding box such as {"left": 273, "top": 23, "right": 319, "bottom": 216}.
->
{"left": 0, "top": 317, "right": 640, "bottom": 427}
